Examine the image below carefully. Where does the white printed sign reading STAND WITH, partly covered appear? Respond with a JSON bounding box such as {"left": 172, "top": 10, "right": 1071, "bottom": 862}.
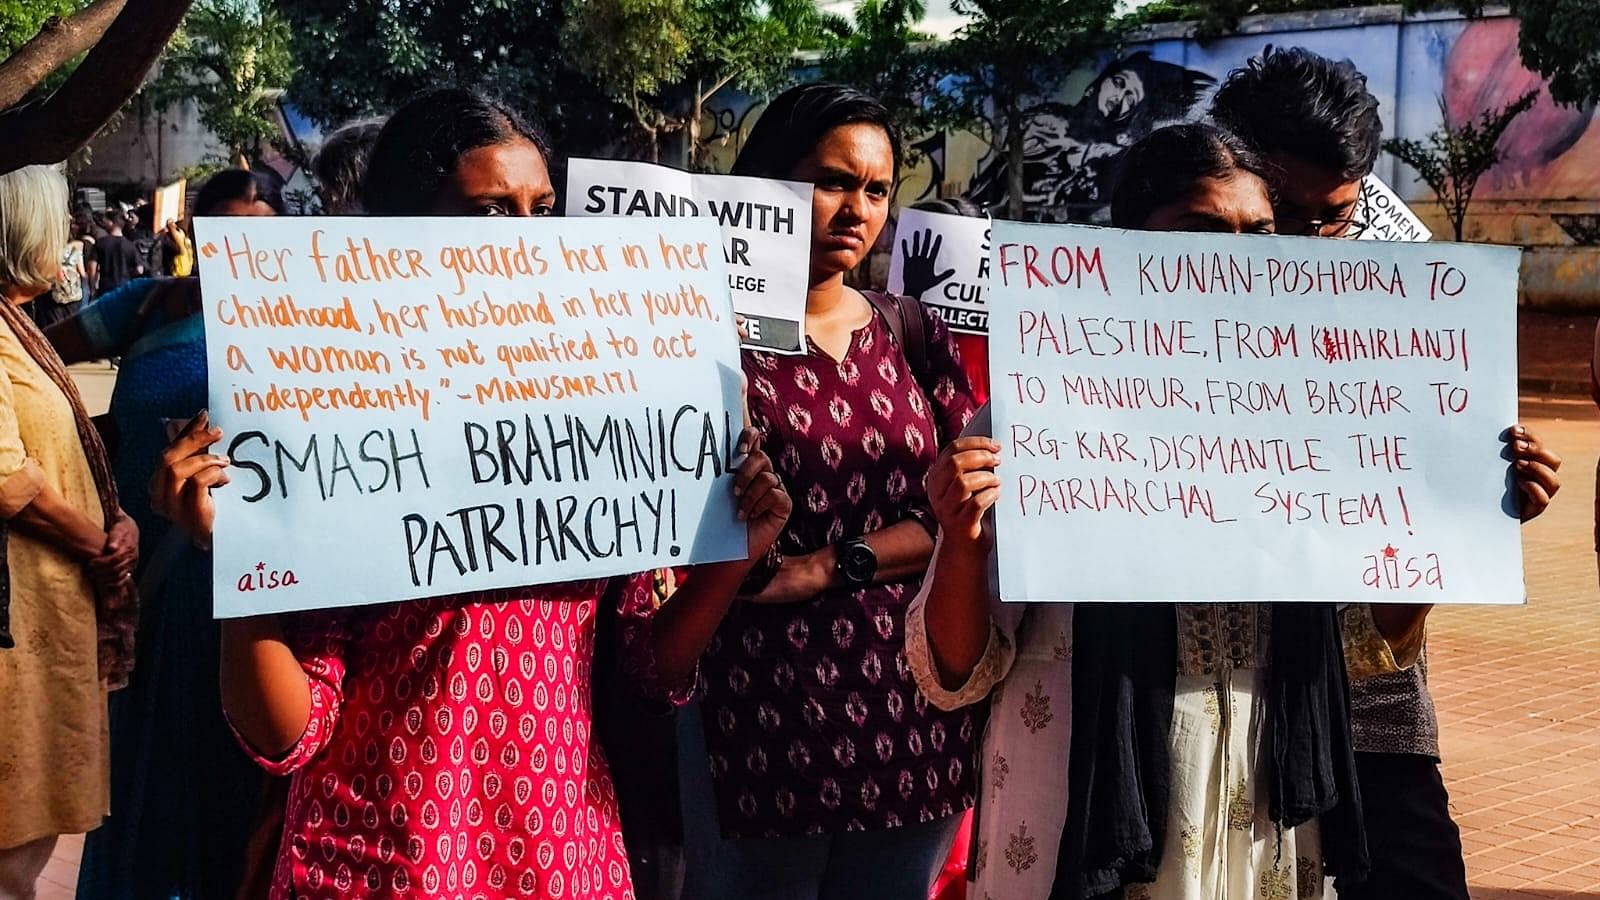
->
{"left": 566, "top": 159, "right": 811, "bottom": 354}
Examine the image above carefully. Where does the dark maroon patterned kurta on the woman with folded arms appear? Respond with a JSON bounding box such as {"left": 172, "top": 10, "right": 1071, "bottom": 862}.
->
{"left": 701, "top": 299, "right": 978, "bottom": 838}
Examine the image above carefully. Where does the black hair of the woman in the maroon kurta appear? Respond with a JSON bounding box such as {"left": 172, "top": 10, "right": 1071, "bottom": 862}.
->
{"left": 733, "top": 83, "right": 901, "bottom": 178}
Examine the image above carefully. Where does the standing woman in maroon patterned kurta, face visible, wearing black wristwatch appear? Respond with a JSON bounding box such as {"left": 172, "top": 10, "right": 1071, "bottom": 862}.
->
{"left": 680, "top": 85, "right": 978, "bottom": 900}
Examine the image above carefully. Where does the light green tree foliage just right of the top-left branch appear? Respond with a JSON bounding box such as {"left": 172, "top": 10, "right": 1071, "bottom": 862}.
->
{"left": 147, "top": 0, "right": 294, "bottom": 159}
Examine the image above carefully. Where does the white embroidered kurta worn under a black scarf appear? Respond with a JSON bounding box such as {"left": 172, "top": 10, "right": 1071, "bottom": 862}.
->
{"left": 906, "top": 408, "right": 1398, "bottom": 900}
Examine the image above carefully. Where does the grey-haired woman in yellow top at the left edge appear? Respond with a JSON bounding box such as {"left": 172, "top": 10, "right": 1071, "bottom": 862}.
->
{"left": 0, "top": 167, "right": 139, "bottom": 900}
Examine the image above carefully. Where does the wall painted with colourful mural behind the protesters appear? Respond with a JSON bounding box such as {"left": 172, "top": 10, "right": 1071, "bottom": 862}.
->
{"left": 707, "top": 8, "right": 1600, "bottom": 265}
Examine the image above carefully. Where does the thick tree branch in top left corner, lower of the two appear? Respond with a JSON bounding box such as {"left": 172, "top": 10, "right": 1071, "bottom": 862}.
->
{"left": 0, "top": 0, "right": 194, "bottom": 175}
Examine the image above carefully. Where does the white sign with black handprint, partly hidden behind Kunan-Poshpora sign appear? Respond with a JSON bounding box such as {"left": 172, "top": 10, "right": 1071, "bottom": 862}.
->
{"left": 888, "top": 208, "right": 989, "bottom": 335}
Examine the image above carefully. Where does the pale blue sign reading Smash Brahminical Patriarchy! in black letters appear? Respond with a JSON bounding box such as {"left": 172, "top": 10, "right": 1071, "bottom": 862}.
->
{"left": 195, "top": 218, "right": 746, "bottom": 618}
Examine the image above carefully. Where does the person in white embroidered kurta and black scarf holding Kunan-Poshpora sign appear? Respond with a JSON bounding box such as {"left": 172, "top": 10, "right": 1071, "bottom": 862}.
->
{"left": 907, "top": 125, "right": 1548, "bottom": 898}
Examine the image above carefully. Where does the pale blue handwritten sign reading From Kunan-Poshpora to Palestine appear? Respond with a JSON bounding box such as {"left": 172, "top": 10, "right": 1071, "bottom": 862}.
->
{"left": 989, "top": 221, "right": 1525, "bottom": 604}
